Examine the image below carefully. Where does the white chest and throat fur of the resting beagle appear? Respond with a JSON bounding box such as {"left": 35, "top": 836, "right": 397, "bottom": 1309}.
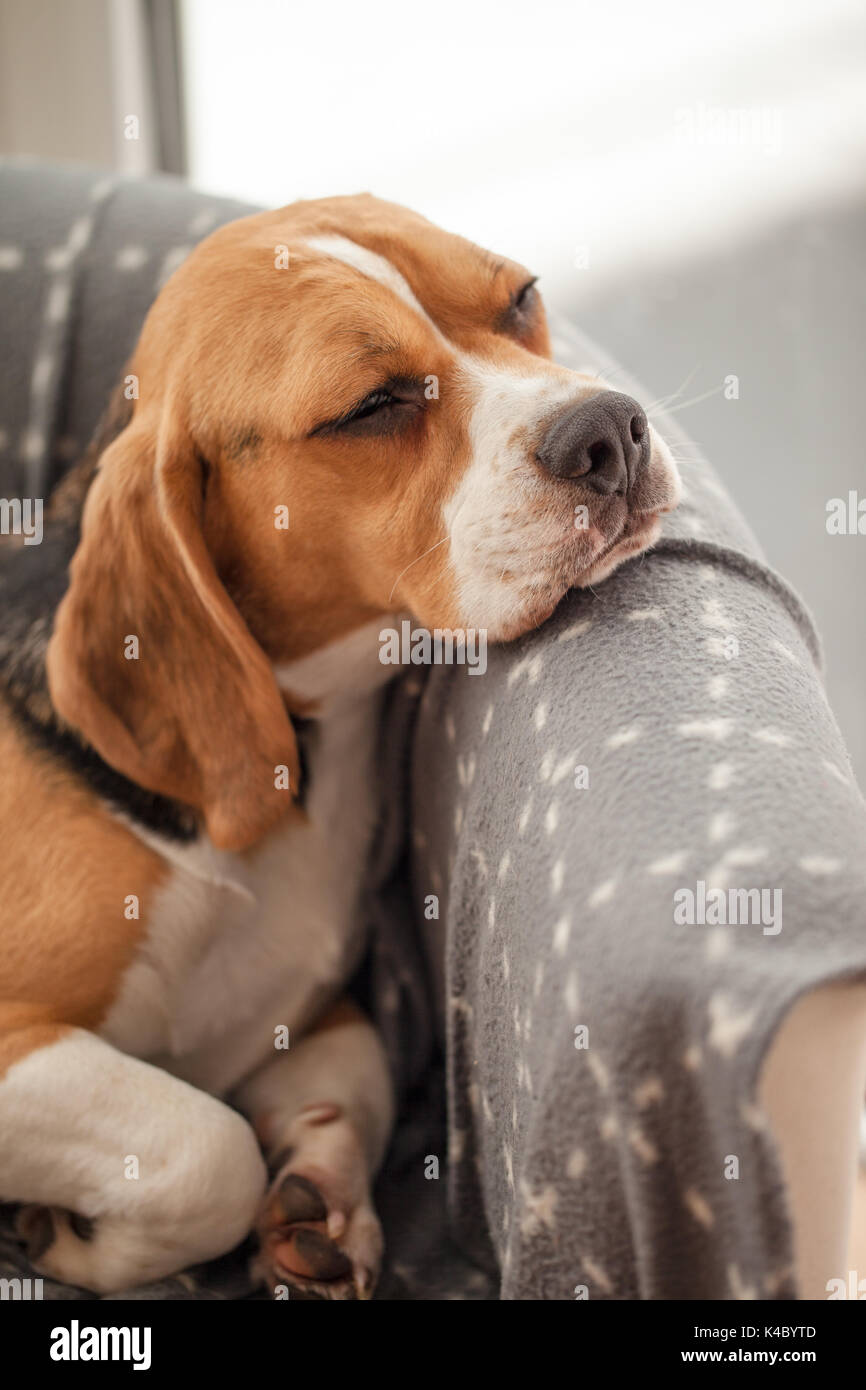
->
{"left": 100, "top": 623, "right": 393, "bottom": 1093}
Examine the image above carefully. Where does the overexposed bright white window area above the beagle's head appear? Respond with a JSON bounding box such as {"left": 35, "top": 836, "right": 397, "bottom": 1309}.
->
{"left": 183, "top": 0, "right": 866, "bottom": 292}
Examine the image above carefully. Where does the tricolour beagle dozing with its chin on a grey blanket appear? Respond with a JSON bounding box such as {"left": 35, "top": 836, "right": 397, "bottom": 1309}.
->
{"left": 0, "top": 195, "right": 678, "bottom": 1298}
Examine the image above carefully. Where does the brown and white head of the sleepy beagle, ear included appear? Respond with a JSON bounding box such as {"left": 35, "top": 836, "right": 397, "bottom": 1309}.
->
{"left": 49, "top": 195, "right": 678, "bottom": 847}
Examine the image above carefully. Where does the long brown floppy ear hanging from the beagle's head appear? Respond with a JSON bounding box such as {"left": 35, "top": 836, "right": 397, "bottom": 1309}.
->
{"left": 47, "top": 414, "right": 299, "bottom": 849}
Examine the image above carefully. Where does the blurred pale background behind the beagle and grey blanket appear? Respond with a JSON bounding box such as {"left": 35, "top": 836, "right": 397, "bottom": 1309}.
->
{"left": 0, "top": 0, "right": 866, "bottom": 785}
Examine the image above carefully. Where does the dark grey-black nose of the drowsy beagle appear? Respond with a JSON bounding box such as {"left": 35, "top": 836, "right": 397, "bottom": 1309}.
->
{"left": 537, "top": 391, "right": 649, "bottom": 493}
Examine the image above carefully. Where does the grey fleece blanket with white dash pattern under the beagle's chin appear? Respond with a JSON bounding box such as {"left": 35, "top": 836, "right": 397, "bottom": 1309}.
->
{"left": 0, "top": 157, "right": 866, "bottom": 1300}
